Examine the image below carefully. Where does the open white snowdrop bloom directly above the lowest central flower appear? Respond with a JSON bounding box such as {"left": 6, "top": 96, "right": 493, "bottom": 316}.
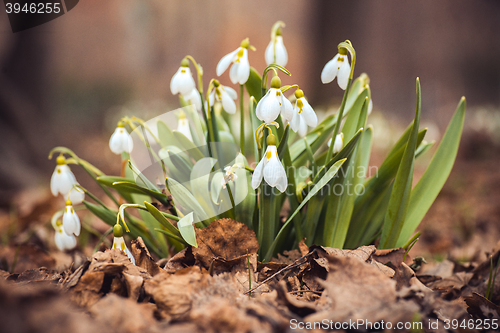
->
{"left": 255, "top": 76, "right": 293, "bottom": 124}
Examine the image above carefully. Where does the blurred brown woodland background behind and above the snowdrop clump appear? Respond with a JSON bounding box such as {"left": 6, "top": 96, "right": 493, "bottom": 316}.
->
{"left": 0, "top": 0, "right": 500, "bottom": 208}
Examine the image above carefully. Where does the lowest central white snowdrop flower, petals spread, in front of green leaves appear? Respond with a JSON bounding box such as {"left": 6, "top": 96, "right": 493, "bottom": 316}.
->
{"left": 252, "top": 134, "right": 287, "bottom": 192}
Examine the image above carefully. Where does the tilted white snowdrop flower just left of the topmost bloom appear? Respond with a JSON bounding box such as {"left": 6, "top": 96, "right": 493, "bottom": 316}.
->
{"left": 216, "top": 38, "right": 252, "bottom": 84}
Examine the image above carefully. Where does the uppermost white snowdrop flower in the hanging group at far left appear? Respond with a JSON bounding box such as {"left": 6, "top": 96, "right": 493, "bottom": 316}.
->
{"left": 50, "top": 155, "right": 85, "bottom": 203}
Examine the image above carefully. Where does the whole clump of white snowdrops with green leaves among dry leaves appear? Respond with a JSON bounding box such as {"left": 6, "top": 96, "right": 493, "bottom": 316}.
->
{"left": 49, "top": 22, "right": 465, "bottom": 261}
